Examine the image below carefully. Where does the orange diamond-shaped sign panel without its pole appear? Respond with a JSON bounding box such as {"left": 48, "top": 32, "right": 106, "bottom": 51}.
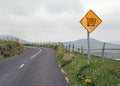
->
{"left": 80, "top": 10, "right": 102, "bottom": 32}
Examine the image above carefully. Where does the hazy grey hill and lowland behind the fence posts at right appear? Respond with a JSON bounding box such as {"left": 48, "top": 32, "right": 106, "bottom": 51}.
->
{"left": 63, "top": 38, "right": 120, "bottom": 59}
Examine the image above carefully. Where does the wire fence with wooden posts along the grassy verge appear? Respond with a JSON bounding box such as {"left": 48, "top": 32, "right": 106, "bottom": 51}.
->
{"left": 65, "top": 43, "right": 120, "bottom": 60}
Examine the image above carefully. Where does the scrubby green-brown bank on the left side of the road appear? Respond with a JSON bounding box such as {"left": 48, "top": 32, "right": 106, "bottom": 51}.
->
{"left": 0, "top": 40, "right": 25, "bottom": 60}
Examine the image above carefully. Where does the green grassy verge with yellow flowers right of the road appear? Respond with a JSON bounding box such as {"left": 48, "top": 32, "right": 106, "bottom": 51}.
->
{"left": 57, "top": 47, "right": 120, "bottom": 86}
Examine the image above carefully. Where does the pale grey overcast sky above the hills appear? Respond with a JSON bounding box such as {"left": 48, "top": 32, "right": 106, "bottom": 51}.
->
{"left": 0, "top": 0, "right": 120, "bottom": 42}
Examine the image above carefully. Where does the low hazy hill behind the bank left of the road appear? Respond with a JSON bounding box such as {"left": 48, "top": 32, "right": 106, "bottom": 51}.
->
{"left": 0, "top": 35, "right": 30, "bottom": 43}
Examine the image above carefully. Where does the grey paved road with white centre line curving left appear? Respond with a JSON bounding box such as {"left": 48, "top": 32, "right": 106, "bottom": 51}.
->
{"left": 0, "top": 47, "right": 69, "bottom": 86}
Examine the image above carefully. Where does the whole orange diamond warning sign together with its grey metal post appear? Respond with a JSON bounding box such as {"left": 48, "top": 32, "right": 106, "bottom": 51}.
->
{"left": 80, "top": 10, "right": 102, "bottom": 65}
